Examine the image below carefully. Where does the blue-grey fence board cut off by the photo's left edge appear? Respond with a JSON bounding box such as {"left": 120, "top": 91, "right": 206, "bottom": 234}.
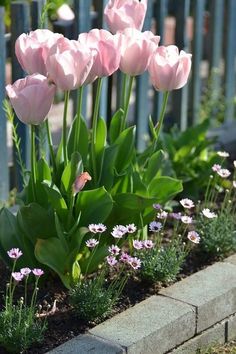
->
{"left": 0, "top": 7, "right": 9, "bottom": 201}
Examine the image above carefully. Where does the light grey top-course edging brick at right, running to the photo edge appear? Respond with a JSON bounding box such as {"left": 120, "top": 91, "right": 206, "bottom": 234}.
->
{"left": 160, "top": 262, "right": 236, "bottom": 333}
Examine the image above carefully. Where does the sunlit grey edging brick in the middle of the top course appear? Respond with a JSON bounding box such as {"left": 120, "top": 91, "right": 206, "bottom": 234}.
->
{"left": 89, "top": 296, "right": 196, "bottom": 354}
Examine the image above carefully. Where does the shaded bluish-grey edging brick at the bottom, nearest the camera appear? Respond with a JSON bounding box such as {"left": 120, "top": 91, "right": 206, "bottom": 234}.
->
{"left": 47, "top": 334, "right": 125, "bottom": 354}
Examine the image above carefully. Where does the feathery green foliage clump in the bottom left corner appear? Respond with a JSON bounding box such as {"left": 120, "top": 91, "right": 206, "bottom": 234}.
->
{"left": 0, "top": 304, "right": 46, "bottom": 353}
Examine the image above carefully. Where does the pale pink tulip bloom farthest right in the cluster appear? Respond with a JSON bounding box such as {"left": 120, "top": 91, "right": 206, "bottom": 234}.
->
{"left": 148, "top": 45, "right": 192, "bottom": 91}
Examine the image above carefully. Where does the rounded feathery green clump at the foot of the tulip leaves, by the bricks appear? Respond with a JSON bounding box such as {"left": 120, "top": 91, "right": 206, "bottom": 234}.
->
{"left": 70, "top": 277, "right": 118, "bottom": 321}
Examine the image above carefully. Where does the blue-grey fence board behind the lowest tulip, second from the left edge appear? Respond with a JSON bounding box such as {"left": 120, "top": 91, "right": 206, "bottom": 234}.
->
{"left": 11, "top": 1, "right": 30, "bottom": 189}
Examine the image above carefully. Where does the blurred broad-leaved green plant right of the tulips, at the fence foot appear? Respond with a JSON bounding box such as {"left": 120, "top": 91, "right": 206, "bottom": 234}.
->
{"left": 160, "top": 120, "right": 218, "bottom": 199}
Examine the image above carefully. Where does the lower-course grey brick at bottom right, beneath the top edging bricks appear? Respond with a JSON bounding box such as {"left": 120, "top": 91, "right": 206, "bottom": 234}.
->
{"left": 168, "top": 321, "right": 226, "bottom": 354}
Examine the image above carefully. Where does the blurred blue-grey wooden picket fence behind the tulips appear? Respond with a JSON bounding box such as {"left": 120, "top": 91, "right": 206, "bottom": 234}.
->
{"left": 0, "top": 0, "right": 236, "bottom": 200}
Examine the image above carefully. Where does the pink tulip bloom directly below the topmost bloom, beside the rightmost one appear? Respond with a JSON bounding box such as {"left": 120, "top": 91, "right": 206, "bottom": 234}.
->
{"left": 120, "top": 28, "right": 160, "bottom": 76}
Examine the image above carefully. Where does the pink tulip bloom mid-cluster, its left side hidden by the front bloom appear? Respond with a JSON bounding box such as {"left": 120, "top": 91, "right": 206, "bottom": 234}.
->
{"left": 79, "top": 29, "right": 120, "bottom": 84}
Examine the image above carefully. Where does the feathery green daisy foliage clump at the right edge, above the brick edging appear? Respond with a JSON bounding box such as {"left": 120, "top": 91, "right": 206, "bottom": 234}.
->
{"left": 196, "top": 211, "right": 236, "bottom": 258}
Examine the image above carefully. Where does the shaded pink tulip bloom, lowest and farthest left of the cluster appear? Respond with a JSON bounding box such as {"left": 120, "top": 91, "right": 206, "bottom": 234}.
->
{"left": 6, "top": 74, "right": 56, "bottom": 125}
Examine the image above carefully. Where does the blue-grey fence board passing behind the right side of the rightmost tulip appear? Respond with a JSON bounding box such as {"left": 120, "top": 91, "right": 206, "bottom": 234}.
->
{"left": 173, "top": 0, "right": 190, "bottom": 130}
